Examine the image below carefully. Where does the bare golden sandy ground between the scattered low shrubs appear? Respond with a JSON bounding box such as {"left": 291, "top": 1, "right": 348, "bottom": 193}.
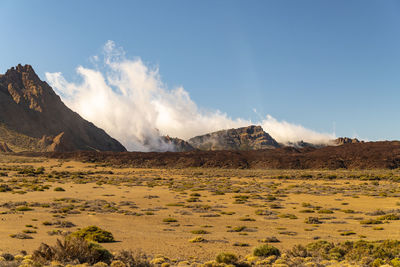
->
{"left": 0, "top": 155, "right": 400, "bottom": 259}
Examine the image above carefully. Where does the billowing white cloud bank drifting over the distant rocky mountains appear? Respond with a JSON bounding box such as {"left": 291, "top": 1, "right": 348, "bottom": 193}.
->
{"left": 46, "top": 41, "right": 334, "bottom": 151}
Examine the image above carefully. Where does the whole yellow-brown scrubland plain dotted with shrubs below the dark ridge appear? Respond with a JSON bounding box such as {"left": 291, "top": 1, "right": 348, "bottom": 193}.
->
{"left": 0, "top": 154, "right": 400, "bottom": 266}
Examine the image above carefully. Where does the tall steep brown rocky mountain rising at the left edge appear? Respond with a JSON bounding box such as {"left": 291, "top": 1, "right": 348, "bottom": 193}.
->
{"left": 0, "top": 65, "right": 126, "bottom": 151}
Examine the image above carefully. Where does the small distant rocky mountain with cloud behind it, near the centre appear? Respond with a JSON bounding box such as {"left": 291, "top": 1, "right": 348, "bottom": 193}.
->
{"left": 187, "top": 125, "right": 280, "bottom": 150}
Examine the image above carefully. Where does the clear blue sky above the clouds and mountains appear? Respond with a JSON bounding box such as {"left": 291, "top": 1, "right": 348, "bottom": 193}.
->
{"left": 0, "top": 0, "right": 400, "bottom": 140}
